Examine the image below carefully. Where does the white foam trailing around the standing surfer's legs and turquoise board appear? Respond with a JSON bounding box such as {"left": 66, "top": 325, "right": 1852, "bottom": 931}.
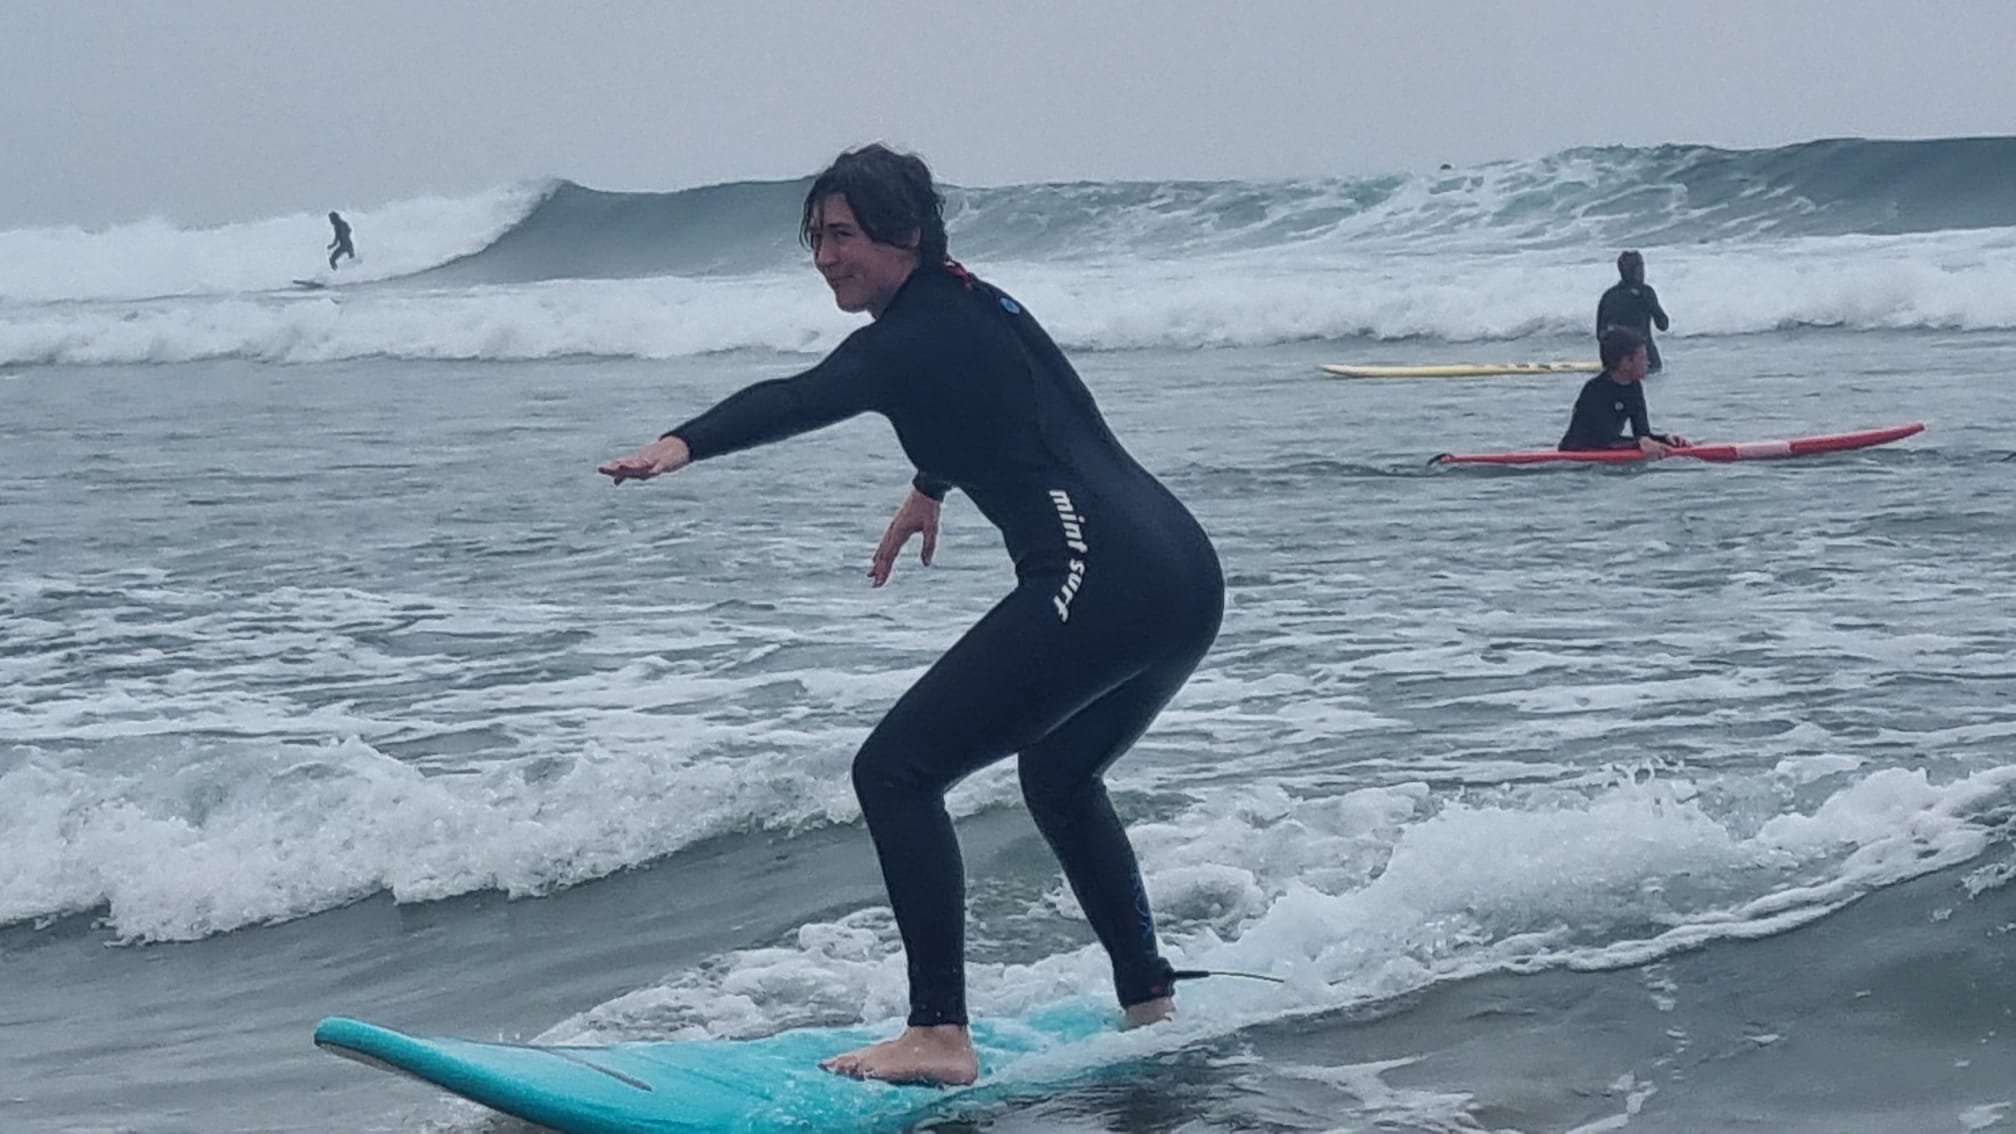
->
{"left": 544, "top": 769, "right": 2016, "bottom": 1041}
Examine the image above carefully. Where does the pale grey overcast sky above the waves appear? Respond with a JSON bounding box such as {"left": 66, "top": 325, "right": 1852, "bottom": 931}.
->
{"left": 0, "top": 0, "right": 2016, "bottom": 228}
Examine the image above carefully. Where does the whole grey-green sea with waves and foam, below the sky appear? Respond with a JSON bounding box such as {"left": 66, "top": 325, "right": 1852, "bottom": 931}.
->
{"left": 0, "top": 139, "right": 2016, "bottom": 1134}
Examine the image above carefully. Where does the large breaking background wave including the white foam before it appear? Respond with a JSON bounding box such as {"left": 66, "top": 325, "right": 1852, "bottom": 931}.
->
{"left": 0, "top": 139, "right": 2016, "bottom": 365}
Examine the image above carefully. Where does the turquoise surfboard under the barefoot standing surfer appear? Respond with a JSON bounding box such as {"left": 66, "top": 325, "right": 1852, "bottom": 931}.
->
{"left": 314, "top": 1001, "right": 1117, "bottom": 1134}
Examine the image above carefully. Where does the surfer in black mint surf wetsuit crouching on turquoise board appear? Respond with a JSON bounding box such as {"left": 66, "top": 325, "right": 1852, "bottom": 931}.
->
{"left": 599, "top": 145, "right": 1224, "bottom": 1084}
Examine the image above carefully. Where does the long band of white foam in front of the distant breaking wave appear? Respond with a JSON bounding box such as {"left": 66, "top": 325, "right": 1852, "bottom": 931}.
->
{"left": 0, "top": 222, "right": 2016, "bottom": 365}
